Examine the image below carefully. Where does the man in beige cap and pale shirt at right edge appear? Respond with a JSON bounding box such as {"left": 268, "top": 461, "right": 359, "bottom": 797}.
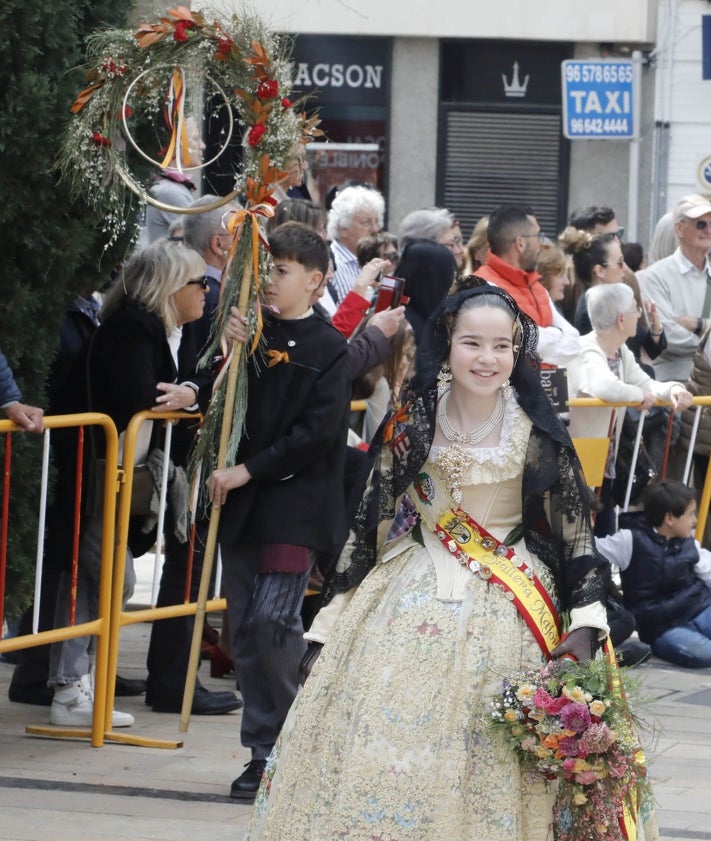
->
{"left": 639, "top": 194, "right": 711, "bottom": 382}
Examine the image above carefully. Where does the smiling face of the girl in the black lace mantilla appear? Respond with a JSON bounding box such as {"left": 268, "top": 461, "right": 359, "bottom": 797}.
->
{"left": 449, "top": 306, "right": 514, "bottom": 398}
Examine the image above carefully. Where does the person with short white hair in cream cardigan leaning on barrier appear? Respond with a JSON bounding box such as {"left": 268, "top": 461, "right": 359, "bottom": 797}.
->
{"left": 568, "top": 283, "right": 692, "bottom": 535}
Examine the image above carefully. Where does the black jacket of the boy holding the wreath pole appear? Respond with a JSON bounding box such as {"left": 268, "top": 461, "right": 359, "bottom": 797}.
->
{"left": 220, "top": 314, "right": 350, "bottom": 552}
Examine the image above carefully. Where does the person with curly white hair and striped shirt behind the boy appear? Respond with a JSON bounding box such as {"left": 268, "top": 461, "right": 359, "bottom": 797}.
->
{"left": 327, "top": 186, "right": 385, "bottom": 304}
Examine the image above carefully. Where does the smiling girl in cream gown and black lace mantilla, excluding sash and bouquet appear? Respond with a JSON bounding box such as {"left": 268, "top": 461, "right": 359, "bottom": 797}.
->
{"left": 248, "top": 284, "right": 607, "bottom": 841}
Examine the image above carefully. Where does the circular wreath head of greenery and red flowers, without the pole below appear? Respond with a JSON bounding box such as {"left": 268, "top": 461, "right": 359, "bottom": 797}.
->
{"left": 59, "top": 6, "right": 320, "bottom": 243}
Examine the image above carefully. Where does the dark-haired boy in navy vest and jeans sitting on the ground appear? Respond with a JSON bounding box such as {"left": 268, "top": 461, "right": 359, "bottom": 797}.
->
{"left": 596, "top": 479, "right": 711, "bottom": 669}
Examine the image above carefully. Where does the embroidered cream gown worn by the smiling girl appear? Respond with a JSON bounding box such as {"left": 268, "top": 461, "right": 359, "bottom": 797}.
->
{"left": 248, "top": 401, "right": 553, "bottom": 841}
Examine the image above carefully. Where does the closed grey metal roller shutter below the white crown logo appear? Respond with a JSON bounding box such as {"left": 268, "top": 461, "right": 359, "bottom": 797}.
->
{"left": 442, "top": 109, "right": 561, "bottom": 242}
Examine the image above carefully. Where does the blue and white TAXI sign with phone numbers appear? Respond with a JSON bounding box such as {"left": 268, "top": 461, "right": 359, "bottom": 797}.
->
{"left": 561, "top": 59, "right": 638, "bottom": 140}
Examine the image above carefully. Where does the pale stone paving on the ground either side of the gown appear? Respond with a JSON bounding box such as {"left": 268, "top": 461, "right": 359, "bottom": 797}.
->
{"left": 0, "top": 612, "right": 711, "bottom": 841}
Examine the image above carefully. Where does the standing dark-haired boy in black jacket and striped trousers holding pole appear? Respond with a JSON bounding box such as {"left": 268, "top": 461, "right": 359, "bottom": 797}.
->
{"left": 208, "top": 222, "right": 350, "bottom": 800}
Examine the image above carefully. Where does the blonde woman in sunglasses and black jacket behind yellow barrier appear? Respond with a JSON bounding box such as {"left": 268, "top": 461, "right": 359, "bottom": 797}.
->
{"left": 48, "top": 239, "right": 207, "bottom": 727}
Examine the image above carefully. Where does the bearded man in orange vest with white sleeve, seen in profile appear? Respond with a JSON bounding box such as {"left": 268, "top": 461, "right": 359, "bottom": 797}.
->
{"left": 476, "top": 204, "right": 580, "bottom": 366}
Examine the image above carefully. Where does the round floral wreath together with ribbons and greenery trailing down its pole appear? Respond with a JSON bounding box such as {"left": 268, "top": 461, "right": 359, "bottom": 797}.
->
{"left": 59, "top": 6, "right": 321, "bottom": 486}
